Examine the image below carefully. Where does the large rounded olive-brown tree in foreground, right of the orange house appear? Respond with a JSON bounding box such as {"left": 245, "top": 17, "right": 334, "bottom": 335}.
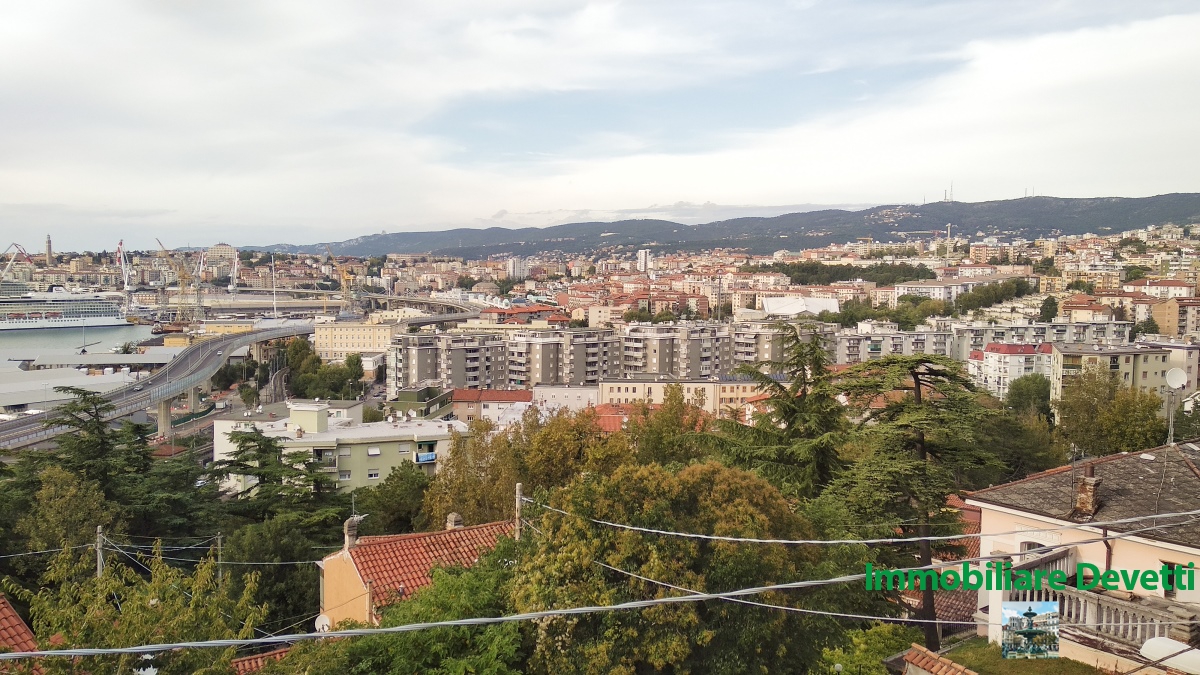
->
{"left": 512, "top": 462, "right": 883, "bottom": 674}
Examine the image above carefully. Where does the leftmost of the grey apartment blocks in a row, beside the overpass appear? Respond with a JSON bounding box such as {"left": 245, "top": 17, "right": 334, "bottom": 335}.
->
{"left": 386, "top": 333, "right": 508, "bottom": 399}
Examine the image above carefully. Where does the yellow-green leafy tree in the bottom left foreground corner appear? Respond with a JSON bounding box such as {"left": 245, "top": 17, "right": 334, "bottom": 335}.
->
{"left": 5, "top": 551, "right": 265, "bottom": 675}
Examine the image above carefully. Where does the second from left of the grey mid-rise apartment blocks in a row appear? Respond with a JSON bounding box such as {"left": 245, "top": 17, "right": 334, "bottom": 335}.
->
{"left": 506, "top": 328, "right": 622, "bottom": 388}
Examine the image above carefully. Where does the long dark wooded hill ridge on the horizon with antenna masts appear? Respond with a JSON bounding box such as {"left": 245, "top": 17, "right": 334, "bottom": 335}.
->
{"left": 259, "top": 193, "right": 1200, "bottom": 258}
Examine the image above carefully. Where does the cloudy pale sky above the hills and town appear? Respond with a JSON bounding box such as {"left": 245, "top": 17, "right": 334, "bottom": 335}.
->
{"left": 0, "top": 0, "right": 1200, "bottom": 250}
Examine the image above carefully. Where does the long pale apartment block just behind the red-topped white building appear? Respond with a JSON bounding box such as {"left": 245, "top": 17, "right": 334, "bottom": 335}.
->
{"left": 946, "top": 321, "right": 1133, "bottom": 362}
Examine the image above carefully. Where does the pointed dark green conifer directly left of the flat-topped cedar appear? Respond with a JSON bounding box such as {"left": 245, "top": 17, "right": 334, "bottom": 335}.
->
{"left": 714, "top": 323, "right": 847, "bottom": 497}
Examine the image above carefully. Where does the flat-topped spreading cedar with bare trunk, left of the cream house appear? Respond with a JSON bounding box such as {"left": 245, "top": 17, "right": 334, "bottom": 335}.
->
{"left": 840, "top": 354, "right": 998, "bottom": 651}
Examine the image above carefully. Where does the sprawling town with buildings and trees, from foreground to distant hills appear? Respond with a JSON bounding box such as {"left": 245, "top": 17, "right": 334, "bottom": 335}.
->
{"left": 7, "top": 218, "right": 1200, "bottom": 674}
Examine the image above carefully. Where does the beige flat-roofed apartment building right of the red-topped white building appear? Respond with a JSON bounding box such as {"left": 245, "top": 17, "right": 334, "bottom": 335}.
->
{"left": 1050, "top": 342, "right": 1171, "bottom": 400}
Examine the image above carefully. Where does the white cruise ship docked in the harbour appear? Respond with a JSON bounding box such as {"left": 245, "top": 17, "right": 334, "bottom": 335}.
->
{"left": 0, "top": 284, "right": 128, "bottom": 330}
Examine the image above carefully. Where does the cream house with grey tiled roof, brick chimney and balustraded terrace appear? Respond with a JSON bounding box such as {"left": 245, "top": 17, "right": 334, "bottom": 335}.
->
{"left": 967, "top": 442, "right": 1200, "bottom": 674}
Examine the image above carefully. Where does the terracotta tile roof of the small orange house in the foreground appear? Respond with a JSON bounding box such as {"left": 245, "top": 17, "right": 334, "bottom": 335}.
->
{"left": 350, "top": 520, "right": 512, "bottom": 605}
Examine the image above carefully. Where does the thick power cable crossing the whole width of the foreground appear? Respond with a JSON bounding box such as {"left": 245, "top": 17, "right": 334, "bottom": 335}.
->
{"left": 7, "top": 514, "right": 1195, "bottom": 661}
